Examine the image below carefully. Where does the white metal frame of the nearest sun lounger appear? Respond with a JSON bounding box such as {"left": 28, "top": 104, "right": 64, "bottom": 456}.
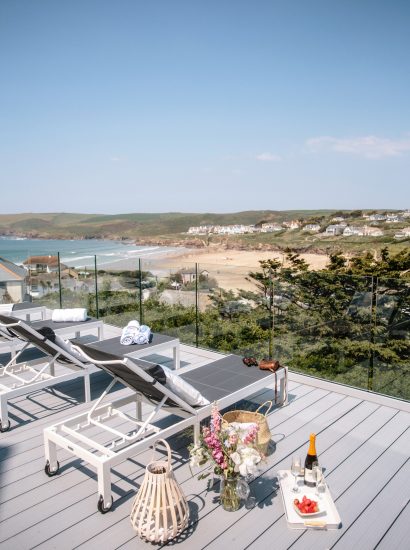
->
{"left": 40, "top": 357, "right": 287, "bottom": 513}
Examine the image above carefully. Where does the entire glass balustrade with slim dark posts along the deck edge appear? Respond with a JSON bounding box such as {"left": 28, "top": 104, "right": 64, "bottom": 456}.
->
{"left": 0, "top": 250, "right": 410, "bottom": 399}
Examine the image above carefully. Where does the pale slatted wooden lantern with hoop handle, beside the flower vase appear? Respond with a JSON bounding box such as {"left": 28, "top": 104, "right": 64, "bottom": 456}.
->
{"left": 130, "top": 439, "right": 189, "bottom": 543}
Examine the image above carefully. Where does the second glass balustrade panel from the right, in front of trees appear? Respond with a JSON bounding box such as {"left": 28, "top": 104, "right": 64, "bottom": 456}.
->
{"left": 274, "top": 270, "right": 372, "bottom": 388}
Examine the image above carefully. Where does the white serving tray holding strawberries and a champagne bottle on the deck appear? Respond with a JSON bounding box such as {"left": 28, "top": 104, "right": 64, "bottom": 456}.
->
{"left": 278, "top": 470, "right": 342, "bottom": 529}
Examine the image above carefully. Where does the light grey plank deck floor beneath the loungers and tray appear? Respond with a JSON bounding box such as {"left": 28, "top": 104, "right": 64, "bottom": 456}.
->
{"left": 0, "top": 330, "right": 410, "bottom": 550}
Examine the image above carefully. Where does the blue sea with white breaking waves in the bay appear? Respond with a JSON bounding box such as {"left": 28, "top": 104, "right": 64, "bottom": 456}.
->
{"left": 0, "top": 236, "right": 188, "bottom": 269}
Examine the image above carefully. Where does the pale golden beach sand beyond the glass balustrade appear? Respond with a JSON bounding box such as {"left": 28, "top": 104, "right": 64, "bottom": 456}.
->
{"left": 105, "top": 247, "right": 329, "bottom": 290}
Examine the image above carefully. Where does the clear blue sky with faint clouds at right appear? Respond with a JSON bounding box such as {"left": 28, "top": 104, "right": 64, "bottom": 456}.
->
{"left": 0, "top": 0, "right": 410, "bottom": 213}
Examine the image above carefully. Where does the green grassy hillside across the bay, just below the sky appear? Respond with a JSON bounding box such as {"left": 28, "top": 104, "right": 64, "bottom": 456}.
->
{"left": 0, "top": 210, "right": 410, "bottom": 253}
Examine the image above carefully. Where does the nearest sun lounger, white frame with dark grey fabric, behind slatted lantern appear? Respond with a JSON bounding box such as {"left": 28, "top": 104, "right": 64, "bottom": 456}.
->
{"left": 40, "top": 343, "right": 287, "bottom": 513}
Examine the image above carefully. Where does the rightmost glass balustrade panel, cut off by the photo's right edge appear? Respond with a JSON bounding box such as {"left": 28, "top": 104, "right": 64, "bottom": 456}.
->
{"left": 371, "top": 279, "right": 410, "bottom": 399}
